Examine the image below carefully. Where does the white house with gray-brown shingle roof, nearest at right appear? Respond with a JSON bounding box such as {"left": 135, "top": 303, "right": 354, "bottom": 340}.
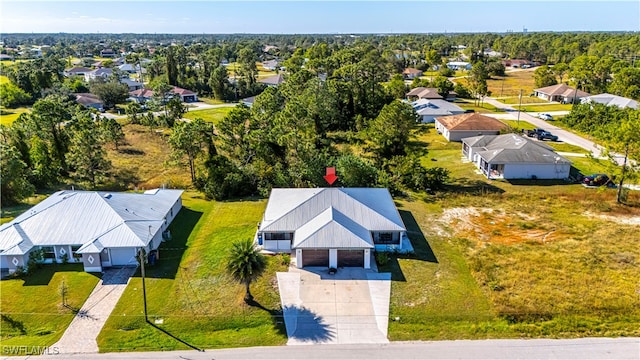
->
{"left": 462, "top": 134, "right": 571, "bottom": 179}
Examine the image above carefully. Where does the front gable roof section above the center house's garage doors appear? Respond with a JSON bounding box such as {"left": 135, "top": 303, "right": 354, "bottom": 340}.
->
{"left": 293, "top": 207, "right": 373, "bottom": 249}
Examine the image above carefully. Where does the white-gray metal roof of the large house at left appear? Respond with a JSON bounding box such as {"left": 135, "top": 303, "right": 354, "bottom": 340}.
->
{"left": 0, "top": 189, "right": 182, "bottom": 255}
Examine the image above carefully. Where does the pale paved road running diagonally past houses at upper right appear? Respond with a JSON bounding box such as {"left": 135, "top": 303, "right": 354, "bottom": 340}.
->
{"left": 484, "top": 98, "right": 624, "bottom": 164}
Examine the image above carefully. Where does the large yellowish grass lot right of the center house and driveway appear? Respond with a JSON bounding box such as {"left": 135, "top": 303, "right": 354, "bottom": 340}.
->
{"left": 383, "top": 181, "right": 640, "bottom": 340}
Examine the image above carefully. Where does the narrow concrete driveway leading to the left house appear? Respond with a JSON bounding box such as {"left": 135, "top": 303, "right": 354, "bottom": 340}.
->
{"left": 51, "top": 267, "right": 136, "bottom": 354}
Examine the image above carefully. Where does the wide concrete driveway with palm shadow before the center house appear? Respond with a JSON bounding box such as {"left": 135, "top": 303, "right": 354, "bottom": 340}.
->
{"left": 277, "top": 267, "right": 391, "bottom": 345}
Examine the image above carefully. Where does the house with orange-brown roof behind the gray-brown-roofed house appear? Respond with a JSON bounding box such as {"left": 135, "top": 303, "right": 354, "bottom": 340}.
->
{"left": 435, "top": 113, "right": 508, "bottom": 141}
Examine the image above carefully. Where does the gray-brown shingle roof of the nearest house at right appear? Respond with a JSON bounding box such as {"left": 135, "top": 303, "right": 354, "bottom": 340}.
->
{"left": 463, "top": 134, "right": 571, "bottom": 164}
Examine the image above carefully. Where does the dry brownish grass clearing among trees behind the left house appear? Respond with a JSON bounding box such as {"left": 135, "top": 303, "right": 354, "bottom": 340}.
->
{"left": 107, "top": 124, "right": 191, "bottom": 190}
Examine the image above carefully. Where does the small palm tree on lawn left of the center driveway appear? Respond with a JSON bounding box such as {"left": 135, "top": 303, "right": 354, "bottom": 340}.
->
{"left": 227, "top": 239, "right": 267, "bottom": 302}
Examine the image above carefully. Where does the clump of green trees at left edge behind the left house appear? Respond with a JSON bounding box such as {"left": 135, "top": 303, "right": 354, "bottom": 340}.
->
{"left": 0, "top": 94, "right": 119, "bottom": 205}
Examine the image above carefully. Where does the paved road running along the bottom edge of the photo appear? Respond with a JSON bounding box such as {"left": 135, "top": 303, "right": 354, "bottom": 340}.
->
{"left": 11, "top": 338, "right": 640, "bottom": 360}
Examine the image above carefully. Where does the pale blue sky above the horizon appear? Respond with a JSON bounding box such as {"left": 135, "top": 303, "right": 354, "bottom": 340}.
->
{"left": 0, "top": 0, "right": 640, "bottom": 34}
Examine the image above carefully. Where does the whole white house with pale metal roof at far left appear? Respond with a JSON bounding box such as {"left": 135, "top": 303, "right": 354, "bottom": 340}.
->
{"left": 0, "top": 189, "right": 182, "bottom": 273}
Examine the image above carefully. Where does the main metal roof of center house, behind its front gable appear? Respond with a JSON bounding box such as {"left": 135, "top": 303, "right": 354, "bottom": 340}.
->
{"left": 260, "top": 188, "right": 406, "bottom": 236}
